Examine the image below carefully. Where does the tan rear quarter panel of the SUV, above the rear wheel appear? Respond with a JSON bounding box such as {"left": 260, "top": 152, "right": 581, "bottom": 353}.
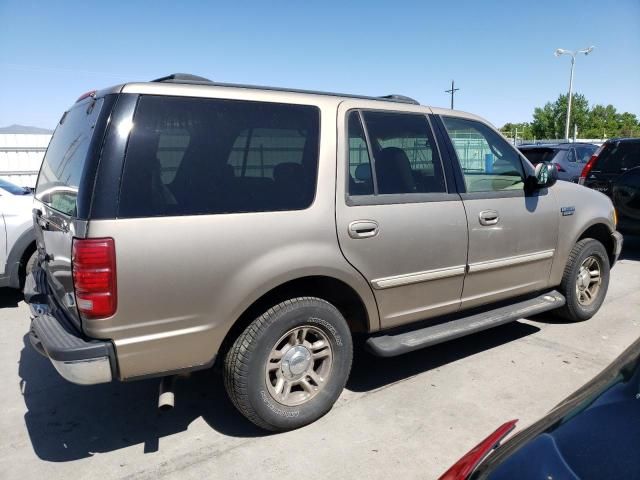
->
{"left": 83, "top": 99, "right": 378, "bottom": 379}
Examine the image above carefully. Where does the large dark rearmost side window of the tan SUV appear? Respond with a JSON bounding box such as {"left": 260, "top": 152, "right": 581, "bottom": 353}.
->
{"left": 118, "top": 96, "right": 320, "bottom": 218}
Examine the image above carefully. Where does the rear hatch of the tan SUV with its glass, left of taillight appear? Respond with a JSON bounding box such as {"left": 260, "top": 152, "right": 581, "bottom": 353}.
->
{"left": 33, "top": 95, "right": 114, "bottom": 327}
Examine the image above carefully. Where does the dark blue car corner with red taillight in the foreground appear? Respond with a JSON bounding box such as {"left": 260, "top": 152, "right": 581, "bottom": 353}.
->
{"left": 440, "top": 340, "right": 640, "bottom": 480}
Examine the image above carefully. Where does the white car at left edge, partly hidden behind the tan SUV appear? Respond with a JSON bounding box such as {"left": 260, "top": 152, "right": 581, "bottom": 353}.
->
{"left": 0, "top": 179, "right": 38, "bottom": 288}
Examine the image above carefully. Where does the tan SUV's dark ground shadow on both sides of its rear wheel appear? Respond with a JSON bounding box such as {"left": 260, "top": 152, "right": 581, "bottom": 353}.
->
{"left": 19, "top": 322, "right": 539, "bottom": 462}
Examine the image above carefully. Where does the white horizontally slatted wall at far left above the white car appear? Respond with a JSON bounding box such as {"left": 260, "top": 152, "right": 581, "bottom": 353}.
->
{"left": 0, "top": 125, "right": 52, "bottom": 187}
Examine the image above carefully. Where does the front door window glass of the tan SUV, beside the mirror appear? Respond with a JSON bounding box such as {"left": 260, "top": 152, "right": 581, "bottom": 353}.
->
{"left": 442, "top": 117, "right": 525, "bottom": 193}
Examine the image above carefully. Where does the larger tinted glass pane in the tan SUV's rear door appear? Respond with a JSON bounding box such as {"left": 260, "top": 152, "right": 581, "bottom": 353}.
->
{"left": 363, "top": 112, "right": 446, "bottom": 194}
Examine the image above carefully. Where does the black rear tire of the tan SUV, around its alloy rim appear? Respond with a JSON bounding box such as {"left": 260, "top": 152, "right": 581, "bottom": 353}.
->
{"left": 224, "top": 297, "right": 353, "bottom": 431}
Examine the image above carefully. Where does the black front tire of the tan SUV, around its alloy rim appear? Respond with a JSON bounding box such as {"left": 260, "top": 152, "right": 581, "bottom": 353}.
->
{"left": 555, "top": 238, "right": 610, "bottom": 322}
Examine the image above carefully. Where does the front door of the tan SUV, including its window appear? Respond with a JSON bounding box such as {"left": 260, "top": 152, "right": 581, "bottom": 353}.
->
{"left": 441, "top": 116, "right": 559, "bottom": 308}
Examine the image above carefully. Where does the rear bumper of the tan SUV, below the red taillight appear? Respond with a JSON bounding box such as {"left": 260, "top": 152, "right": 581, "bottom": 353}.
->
{"left": 25, "top": 269, "right": 116, "bottom": 385}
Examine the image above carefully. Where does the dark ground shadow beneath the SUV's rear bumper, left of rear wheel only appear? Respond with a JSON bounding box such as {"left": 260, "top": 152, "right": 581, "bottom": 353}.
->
{"left": 19, "top": 335, "right": 265, "bottom": 462}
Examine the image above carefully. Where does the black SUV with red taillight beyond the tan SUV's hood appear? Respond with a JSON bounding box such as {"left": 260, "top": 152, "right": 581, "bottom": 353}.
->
{"left": 582, "top": 140, "right": 640, "bottom": 197}
